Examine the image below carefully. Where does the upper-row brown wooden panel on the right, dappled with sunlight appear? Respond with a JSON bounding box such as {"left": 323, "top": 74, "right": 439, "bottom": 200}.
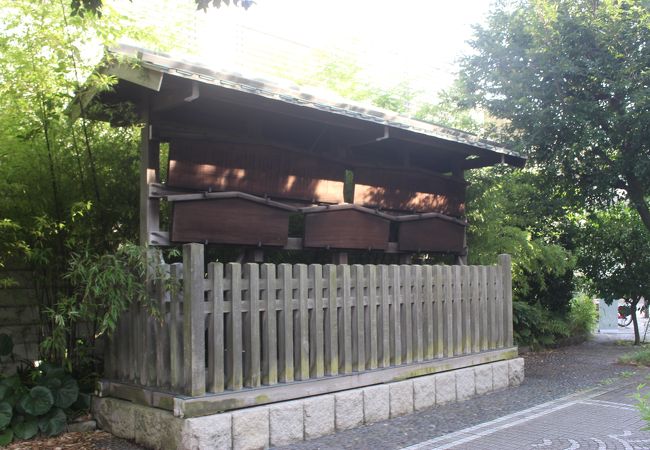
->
{"left": 354, "top": 168, "right": 465, "bottom": 216}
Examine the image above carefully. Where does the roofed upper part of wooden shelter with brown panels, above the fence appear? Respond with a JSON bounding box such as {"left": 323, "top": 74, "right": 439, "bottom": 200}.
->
{"left": 82, "top": 46, "right": 525, "bottom": 262}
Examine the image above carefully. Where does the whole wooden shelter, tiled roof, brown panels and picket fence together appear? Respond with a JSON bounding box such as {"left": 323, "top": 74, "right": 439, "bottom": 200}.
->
{"left": 85, "top": 47, "right": 525, "bottom": 436}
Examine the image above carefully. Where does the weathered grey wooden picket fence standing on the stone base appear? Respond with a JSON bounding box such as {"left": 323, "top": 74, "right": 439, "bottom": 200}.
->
{"left": 106, "top": 244, "right": 512, "bottom": 406}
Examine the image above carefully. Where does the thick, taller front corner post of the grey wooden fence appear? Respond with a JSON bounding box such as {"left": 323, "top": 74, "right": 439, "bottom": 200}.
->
{"left": 183, "top": 244, "right": 205, "bottom": 396}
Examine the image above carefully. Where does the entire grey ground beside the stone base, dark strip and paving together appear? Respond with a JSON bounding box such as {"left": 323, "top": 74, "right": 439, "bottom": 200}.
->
{"left": 284, "top": 330, "right": 650, "bottom": 450}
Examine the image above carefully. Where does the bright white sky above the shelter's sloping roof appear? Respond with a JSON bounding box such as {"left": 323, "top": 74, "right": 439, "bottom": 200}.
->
{"left": 115, "top": 0, "right": 491, "bottom": 99}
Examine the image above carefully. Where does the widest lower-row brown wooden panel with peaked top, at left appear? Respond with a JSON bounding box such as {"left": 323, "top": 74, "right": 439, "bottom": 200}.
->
{"left": 171, "top": 198, "right": 289, "bottom": 246}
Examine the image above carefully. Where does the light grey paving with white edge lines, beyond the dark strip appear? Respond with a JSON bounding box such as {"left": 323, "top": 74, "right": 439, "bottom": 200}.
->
{"left": 404, "top": 377, "right": 650, "bottom": 450}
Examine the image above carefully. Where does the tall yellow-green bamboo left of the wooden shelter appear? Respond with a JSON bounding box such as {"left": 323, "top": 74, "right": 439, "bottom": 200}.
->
{"left": 0, "top": 0, "right": 170, "bottom": 370}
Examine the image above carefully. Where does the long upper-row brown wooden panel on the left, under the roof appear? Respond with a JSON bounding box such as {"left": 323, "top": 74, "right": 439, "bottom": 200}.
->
{"left": 167, "top": 141, "right": 345, "bottom": 203}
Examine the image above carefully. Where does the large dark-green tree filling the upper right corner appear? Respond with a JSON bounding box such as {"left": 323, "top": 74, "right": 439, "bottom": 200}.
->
{"left": 461, "top": 0, "right": 650, "bottom": 230}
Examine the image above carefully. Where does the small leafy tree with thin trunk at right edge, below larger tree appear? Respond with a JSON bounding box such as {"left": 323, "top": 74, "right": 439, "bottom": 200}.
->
{"left": 576, "top": 202, "right": 650, "bottom": 345}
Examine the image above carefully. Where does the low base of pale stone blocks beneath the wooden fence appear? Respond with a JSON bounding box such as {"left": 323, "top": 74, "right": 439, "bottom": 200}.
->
{"left": 92, "top": 358, "right": 524, "bottom": 450}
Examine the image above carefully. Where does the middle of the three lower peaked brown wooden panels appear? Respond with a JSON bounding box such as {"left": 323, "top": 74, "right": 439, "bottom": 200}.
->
{"left": 304, "top": 209, "right": 390, "bottom": 250}
